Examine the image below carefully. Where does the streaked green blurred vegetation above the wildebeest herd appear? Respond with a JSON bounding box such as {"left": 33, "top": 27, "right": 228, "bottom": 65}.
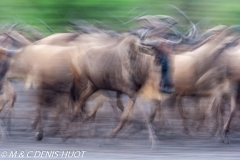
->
{"left": 0, "top": 0, "right": 240, "bottom": 35}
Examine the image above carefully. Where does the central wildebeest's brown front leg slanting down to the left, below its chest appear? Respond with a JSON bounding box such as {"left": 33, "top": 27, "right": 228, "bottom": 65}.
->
{"left": 111, "top": 97, "right": 136, "bottom": 137}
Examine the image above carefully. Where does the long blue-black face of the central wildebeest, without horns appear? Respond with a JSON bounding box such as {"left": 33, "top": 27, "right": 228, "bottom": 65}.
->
{"left": 155, "top": 51, "right": 174, "bottom": 93}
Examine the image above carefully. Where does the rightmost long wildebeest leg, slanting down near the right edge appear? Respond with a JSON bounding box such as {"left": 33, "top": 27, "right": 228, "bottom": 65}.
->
{"left": 223, "top": 90, "right": 236, "bottom": 144}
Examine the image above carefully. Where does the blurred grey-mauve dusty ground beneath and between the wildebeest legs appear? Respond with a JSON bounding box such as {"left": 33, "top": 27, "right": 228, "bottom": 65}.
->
{"left": 0, "top": 82, "right": 240, "bottom": 160}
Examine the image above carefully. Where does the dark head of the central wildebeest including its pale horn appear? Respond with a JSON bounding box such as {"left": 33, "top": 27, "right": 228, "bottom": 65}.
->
{"left": 142, "top": 38, "right": 174, "bottom": 94}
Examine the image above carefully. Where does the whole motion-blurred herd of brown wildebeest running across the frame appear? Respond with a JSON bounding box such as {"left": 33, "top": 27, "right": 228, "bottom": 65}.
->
{"left": 0, "top": 8, "right": 240, "bottom": 149}
